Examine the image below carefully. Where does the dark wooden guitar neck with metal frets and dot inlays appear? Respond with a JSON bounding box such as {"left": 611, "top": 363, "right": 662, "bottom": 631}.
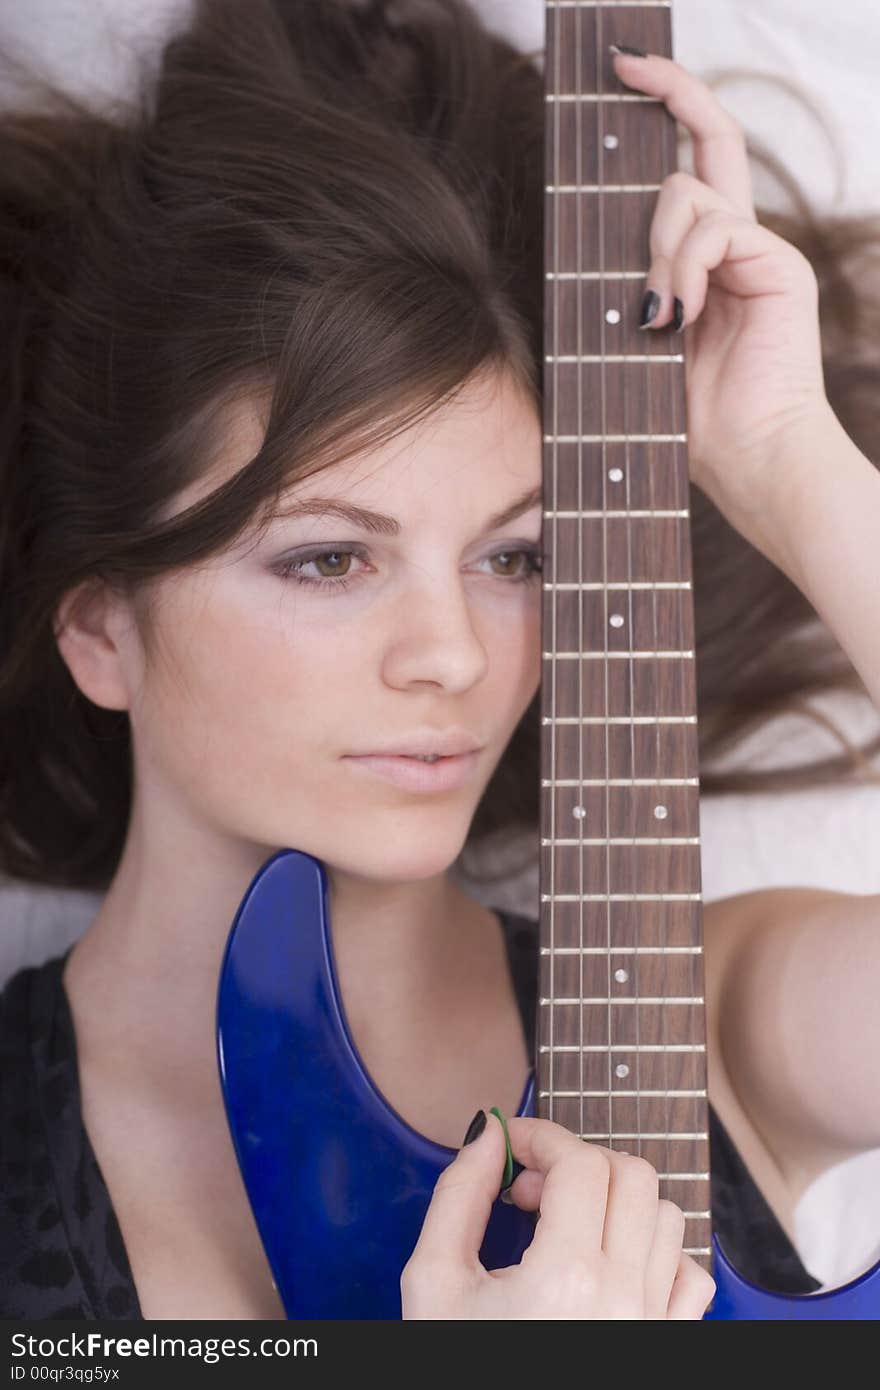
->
{"left": 535, "top": 0, "right": 710, "bottom": 1264}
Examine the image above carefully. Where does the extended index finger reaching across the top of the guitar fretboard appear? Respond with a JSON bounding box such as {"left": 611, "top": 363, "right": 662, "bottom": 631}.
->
{"left": 613, "top": 53, "right": 755, "bottom": 221}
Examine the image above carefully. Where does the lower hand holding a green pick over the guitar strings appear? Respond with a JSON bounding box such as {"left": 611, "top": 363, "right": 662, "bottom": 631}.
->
{"left": 400, "top": 1113, "right": 715, "bottom": 1321}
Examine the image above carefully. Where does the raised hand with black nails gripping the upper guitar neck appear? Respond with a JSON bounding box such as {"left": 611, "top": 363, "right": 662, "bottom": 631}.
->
{"left": 613, "top": 54, "right": 840, "bottom": 552}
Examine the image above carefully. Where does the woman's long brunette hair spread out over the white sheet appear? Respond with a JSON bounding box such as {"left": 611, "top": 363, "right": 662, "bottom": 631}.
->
{"left": 0, "top": 0, "right": 880, "bottom": 890}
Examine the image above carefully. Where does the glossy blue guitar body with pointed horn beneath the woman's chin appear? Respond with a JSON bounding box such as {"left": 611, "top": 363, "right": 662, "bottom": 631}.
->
{"left": 217, "top": 849, "right": 880, "bottom": 1321}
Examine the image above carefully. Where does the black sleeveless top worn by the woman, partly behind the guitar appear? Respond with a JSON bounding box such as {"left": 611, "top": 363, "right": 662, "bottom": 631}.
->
{"left": 0, "top": 909, "right": 820, "bottom": 1319}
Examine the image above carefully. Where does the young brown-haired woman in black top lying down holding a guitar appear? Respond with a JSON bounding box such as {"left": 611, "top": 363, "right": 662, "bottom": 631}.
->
{"left": 0, "top": 0, "right": 880, "bottom": 1319}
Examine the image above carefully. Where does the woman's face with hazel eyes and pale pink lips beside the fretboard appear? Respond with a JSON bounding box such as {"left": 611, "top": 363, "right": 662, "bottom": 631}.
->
{"left": 107, "top": 377, "right": 541, "bottom": 881}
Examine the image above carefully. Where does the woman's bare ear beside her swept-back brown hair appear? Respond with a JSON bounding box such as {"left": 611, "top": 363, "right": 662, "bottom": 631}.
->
{"left": 53, "top": 580, "right": 140, "bottom": 709}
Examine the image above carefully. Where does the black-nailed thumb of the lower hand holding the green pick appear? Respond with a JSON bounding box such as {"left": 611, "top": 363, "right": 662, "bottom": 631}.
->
{"left": 410, "top": 1112, "right": 510, "bottom": 1268}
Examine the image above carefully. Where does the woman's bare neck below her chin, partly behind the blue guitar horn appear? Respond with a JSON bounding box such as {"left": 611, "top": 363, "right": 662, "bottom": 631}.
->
{"left": 64, "top": 795, "right": 480, "bottom": 1104}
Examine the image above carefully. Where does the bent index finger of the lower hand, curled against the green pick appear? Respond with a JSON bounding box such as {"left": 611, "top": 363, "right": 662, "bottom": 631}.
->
{"left": 507, "top": 1116, "right": 610, "bottom": 1262}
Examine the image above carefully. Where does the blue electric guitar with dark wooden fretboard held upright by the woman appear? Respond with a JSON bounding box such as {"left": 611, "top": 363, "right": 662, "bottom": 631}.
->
{"left": 217, "top": 0, "right": 880, "bottom": 1321}
